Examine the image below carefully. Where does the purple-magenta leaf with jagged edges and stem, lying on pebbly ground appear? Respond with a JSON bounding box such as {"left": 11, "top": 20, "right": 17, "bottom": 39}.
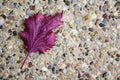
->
{"left": 20, "top": 13, "right": 63, "bottom": 69}
